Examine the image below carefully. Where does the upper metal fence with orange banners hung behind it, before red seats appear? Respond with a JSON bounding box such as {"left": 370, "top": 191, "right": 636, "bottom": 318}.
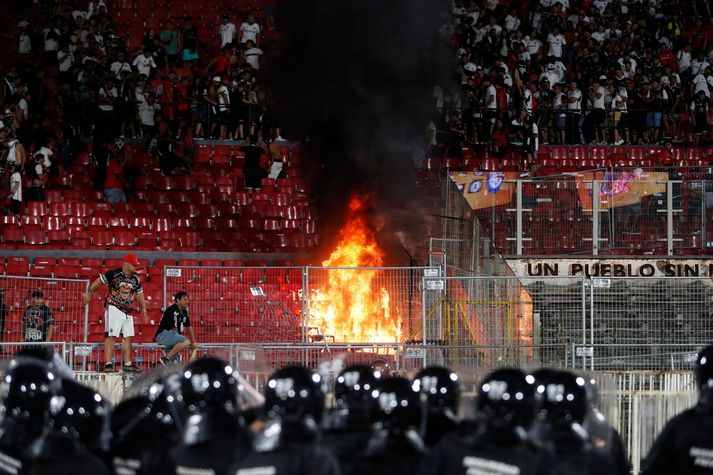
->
{"left": 438, "top": 167, "right": 713, "bottom": 256}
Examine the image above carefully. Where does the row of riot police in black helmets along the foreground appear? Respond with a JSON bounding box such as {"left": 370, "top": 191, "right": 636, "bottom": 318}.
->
{"left": 0, "top": 347, "right": 713, "bottom": 475}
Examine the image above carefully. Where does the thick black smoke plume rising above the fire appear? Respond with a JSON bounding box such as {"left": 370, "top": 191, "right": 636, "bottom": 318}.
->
{"left": 267, "top": 0, "right": 449, "bottom": 264}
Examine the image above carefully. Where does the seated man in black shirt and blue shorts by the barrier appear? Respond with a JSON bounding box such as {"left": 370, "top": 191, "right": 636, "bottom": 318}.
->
{"left": 155, "top": 291, "right": 198, "bottom": 365}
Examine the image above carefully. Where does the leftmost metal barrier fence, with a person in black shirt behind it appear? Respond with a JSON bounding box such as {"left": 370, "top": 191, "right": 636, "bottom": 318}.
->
{"left": 0, "top": 275, "right": 89, "bottom": 342}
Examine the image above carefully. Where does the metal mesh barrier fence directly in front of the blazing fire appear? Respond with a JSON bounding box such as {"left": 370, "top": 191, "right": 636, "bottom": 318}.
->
{"left": 164, "top": 267, "right": 440, "bottom": 344}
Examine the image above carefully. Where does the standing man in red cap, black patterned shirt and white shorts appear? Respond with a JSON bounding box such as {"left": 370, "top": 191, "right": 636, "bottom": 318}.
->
{"left": 84, "top": 254, "right": 146, "bottom": 373}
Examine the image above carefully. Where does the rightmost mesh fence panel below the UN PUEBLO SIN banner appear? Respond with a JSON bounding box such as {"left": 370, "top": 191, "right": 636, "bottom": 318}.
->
{"left": 585, "top": 277, "right": 713, "bottom": 370}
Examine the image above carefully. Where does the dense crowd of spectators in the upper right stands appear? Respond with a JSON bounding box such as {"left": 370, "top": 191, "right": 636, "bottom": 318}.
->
{"left": 427, "top": 0, "right": 713, "bottom": 156}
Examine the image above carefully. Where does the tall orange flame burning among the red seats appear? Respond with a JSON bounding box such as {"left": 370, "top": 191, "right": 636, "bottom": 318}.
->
{"left": 309, "top": 196, "right": 401, "bottom": 343}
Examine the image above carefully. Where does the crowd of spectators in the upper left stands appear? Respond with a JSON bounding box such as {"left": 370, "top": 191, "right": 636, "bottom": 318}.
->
{"left": 0, "top": 0, "right": 281, "bottom": 213}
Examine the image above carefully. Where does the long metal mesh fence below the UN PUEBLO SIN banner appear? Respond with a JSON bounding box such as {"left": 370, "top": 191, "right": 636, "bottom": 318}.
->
{"left": 422, "top": 276, "right": 713, "bottom": 370}
